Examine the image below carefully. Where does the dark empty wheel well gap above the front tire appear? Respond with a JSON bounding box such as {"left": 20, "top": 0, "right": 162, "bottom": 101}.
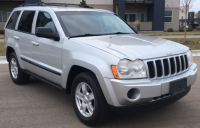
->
{"left": 66, "top": 65, "right": 96, "bottom": 94}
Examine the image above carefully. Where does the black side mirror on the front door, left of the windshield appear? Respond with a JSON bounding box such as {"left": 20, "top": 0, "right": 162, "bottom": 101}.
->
{"left": 35, "top": 27, "right": 60, "bottom": 41}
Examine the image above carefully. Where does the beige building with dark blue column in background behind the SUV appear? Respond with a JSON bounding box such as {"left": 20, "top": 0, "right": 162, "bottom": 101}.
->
{"left": 0, "top": 0, "right": 180, "bottom": 31}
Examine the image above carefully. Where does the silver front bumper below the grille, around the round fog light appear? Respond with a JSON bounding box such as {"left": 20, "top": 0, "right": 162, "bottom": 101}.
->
{"left": 98, "top": 63, "right": 198, "bottom": 107}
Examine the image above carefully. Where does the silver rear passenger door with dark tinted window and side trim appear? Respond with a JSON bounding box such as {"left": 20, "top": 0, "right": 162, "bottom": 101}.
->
{"left": 14, "top": 10, "right": 36, "bottom": 71}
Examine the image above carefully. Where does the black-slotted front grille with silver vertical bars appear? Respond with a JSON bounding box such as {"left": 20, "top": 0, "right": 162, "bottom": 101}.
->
{"left": 146, "top": 54, "right": 188, "bottom": 79}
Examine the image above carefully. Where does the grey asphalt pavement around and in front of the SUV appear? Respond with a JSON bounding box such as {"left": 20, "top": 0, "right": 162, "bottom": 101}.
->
{"left": 0, "top": 57, "right": 200, "bottom": 128}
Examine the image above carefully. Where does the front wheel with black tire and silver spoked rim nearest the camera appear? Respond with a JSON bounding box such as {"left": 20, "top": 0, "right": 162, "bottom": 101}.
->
{"left": 72, "top": 72, "right": 111, "bottom": 126}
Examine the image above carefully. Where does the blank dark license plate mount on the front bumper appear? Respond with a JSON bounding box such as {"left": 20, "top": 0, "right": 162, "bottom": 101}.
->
{"left": 170, "top": 78, "right": 187, "bottom": 95}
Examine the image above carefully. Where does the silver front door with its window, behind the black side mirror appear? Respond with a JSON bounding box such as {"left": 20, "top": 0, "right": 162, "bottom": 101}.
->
{"left": 32, "top": 11, "right": 63, "bottom": 85}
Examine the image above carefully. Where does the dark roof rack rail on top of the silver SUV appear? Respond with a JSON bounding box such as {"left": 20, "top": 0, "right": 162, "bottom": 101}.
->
{"left": 20, "top": 2, "right": 93, "bottom": 8}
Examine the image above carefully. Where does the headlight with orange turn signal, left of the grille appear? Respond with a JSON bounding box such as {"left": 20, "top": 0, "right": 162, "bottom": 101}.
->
{"left": 112, "top": 59, "right": 147, "bottom": 79}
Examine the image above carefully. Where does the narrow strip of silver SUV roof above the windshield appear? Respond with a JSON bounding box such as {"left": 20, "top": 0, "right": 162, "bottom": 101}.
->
{"left": 15, "top": 6, "right": 113, "bottom": 13}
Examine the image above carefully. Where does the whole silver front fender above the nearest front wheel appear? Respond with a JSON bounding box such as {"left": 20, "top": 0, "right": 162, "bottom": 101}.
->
{"left": 62, "top": 39, "right": 120, "bottom": 104}
